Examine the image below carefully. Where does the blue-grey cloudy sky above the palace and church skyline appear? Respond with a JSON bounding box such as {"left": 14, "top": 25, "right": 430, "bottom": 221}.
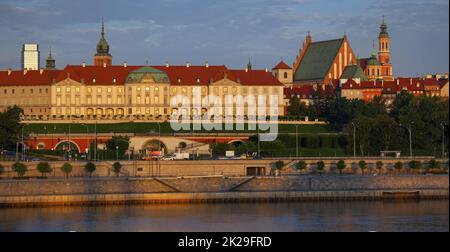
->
{"left": 0, "top": 0, "right": 449, "bottom": 76}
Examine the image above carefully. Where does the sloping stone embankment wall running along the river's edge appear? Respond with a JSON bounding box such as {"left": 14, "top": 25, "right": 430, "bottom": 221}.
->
{"left": 0, "top": 175, "right": 449, "bottom": 207}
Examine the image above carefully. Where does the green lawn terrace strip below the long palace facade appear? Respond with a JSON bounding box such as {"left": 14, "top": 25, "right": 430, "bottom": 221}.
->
{"left": 24, "top": 122, "right": 335, "bottom": 134}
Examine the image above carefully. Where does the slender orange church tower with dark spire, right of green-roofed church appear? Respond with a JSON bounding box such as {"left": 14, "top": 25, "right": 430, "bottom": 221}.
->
{"left": 378, "top": 16, "right": 392, "bottom": 80}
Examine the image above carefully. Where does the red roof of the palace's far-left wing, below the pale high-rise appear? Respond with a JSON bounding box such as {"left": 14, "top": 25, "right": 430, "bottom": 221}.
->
{"left": 0, "top": 70, "right": 61, "bottom": 86}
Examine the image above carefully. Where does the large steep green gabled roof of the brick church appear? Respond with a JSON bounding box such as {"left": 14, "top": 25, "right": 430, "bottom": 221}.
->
{"left": 294, "top": 39, "right": 344, "bottom": 81}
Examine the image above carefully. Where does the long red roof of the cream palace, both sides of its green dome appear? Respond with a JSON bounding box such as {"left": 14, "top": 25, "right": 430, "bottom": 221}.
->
{"left": 0, "top": 65, "right": 283, "bottom": 86}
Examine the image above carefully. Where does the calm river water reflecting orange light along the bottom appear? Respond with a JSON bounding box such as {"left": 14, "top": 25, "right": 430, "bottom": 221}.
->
{"left": 0, "top": 200, "right": 449, "bottom": 232}
